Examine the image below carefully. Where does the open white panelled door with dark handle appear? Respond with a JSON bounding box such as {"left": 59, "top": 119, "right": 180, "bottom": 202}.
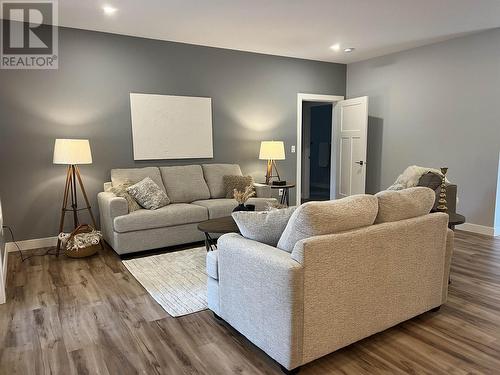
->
{"left": 332, "top": 96, "right": 368, "bottom": 199}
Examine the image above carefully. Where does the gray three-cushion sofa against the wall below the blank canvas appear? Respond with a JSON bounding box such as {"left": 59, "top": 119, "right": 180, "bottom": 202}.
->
{"left": 97, "top": 164, "right": 276, "bottom": 254}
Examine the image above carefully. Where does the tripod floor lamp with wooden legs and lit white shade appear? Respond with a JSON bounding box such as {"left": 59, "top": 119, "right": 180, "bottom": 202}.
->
{"left": 54, "top": 139, "right": 97, "bottom": 256}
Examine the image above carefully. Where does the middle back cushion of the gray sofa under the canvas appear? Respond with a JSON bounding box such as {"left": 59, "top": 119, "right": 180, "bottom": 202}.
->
{"left": 160, "top": 165, "right": 210, "bottom": 203}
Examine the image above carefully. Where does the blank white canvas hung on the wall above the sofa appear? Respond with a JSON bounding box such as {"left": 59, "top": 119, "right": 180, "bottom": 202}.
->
{"left": 130, "top": 93, "right": 213, "bottom": 160}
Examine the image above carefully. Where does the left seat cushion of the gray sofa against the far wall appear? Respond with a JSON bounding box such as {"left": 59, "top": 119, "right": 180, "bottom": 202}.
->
{"left": 113, "top": 203, "right": 208, "bottom": 233}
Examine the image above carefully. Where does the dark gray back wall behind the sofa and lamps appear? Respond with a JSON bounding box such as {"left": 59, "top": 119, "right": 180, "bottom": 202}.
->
{"left": 0, "top": 28, "right": 346, "bottom": 240}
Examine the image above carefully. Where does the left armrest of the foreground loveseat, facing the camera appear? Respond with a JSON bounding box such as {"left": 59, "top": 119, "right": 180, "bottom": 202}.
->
{"left": 218, "top": 233, "right": 303, "bottom": 369}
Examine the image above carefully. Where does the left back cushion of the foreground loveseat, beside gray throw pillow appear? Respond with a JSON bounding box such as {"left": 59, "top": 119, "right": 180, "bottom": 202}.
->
{"left": 277, "top": 195, "right": 378, "bottom": 252}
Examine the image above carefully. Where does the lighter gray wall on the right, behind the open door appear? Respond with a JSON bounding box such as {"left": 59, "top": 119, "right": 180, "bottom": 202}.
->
{"left": 347, "top": 29, "right": 500, "bottom": 227}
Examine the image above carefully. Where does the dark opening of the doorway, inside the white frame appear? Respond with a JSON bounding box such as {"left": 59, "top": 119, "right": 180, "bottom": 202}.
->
{"left": 300, "top": 101, "right": 334, "bottom": 203}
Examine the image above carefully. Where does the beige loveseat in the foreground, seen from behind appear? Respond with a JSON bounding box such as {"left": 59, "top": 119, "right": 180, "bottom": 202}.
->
{"left": 207, "top": 187, "right": 453, "bottom": 372}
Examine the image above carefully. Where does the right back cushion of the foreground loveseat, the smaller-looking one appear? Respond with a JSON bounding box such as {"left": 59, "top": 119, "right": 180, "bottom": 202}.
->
{"left": 375, "top": 187, "right": 436, "bottom": 223}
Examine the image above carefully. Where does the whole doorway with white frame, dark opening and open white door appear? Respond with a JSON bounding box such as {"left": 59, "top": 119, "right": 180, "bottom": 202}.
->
{"left": 296, "top": 93, "right": 368, "bottom": 205}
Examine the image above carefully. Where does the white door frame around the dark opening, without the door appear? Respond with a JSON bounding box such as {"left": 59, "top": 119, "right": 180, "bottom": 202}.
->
{"left": 295, "top": 93, "right": 344, "bottom": 206}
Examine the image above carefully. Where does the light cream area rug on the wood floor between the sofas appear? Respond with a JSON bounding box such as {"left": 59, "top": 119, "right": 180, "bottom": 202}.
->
{"left": 123, "top": 247, "right": 207, "bottom": 317}
